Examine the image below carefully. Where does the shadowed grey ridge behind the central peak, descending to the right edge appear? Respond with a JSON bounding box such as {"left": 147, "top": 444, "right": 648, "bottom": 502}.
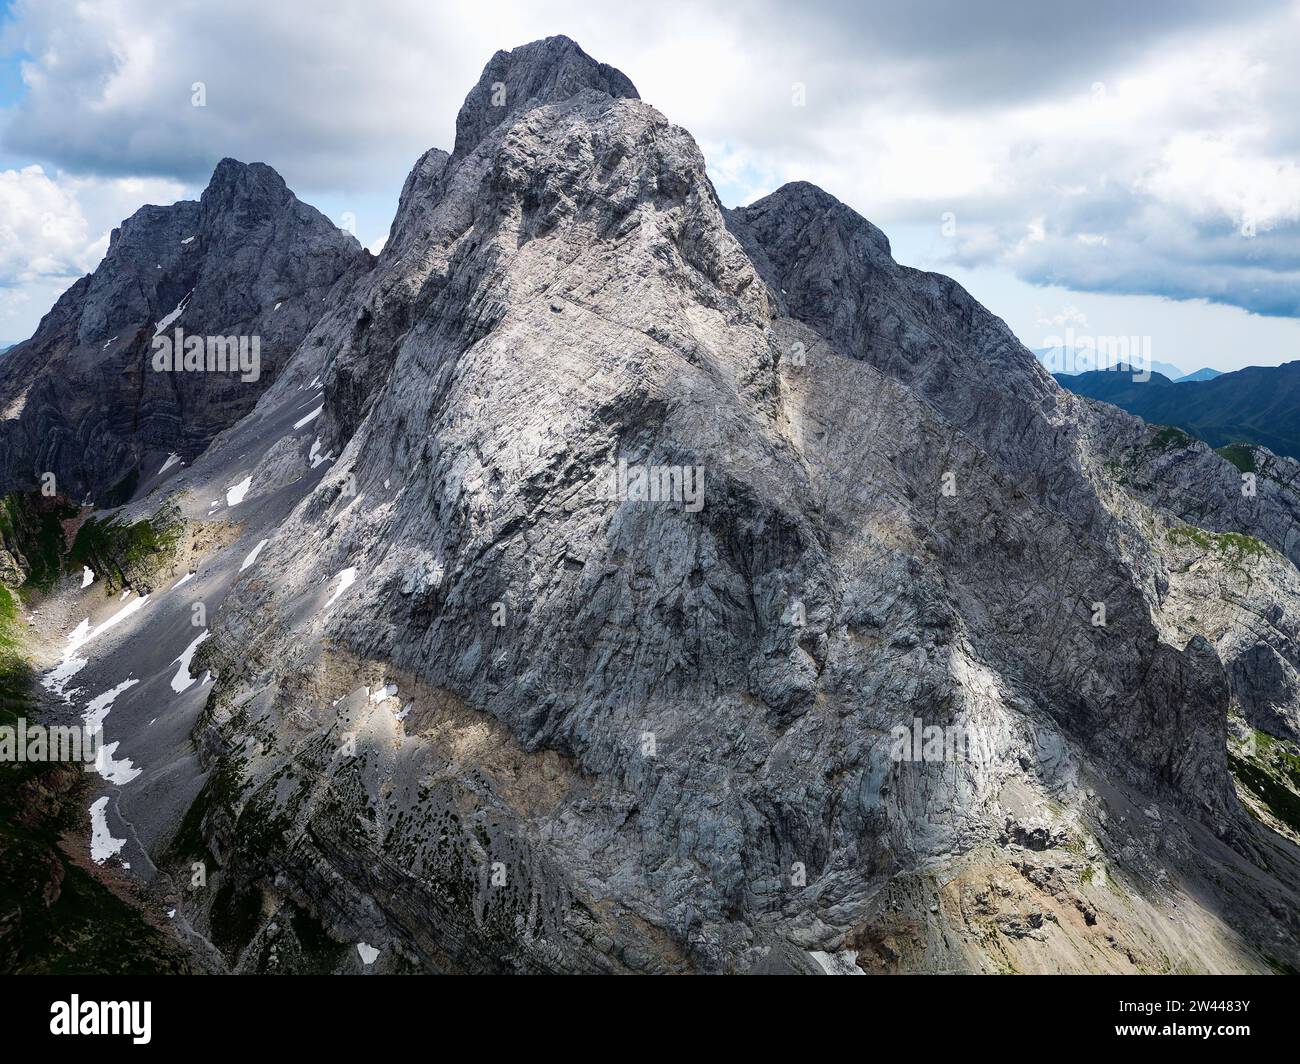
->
{"left": 728, "top": 183, "right": 1300, "bottom": 738}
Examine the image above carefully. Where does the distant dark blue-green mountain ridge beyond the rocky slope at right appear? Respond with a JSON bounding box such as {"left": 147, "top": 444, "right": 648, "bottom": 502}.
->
{"left": 1057, "top": 362, "right": 1300, "bottom": 458}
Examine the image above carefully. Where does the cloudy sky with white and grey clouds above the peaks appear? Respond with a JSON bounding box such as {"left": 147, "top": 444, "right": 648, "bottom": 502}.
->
{"left": 0, "top": 0, "right": 1300, "bottom": 371}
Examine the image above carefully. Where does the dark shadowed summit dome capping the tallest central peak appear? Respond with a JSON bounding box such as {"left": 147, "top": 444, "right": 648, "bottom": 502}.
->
{"left": 452, "top": 36, "right": 641, "bottom": 156}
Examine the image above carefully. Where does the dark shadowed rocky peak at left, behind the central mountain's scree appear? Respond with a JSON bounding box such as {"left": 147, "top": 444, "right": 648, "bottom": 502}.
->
{"left": 0, "top": 159, "right": 369, "bottom": 502}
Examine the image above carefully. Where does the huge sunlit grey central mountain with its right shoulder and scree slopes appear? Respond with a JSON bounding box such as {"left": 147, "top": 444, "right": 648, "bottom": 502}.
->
{"left": 7, "top": 38, "right": 1300, "bottom": 974}
